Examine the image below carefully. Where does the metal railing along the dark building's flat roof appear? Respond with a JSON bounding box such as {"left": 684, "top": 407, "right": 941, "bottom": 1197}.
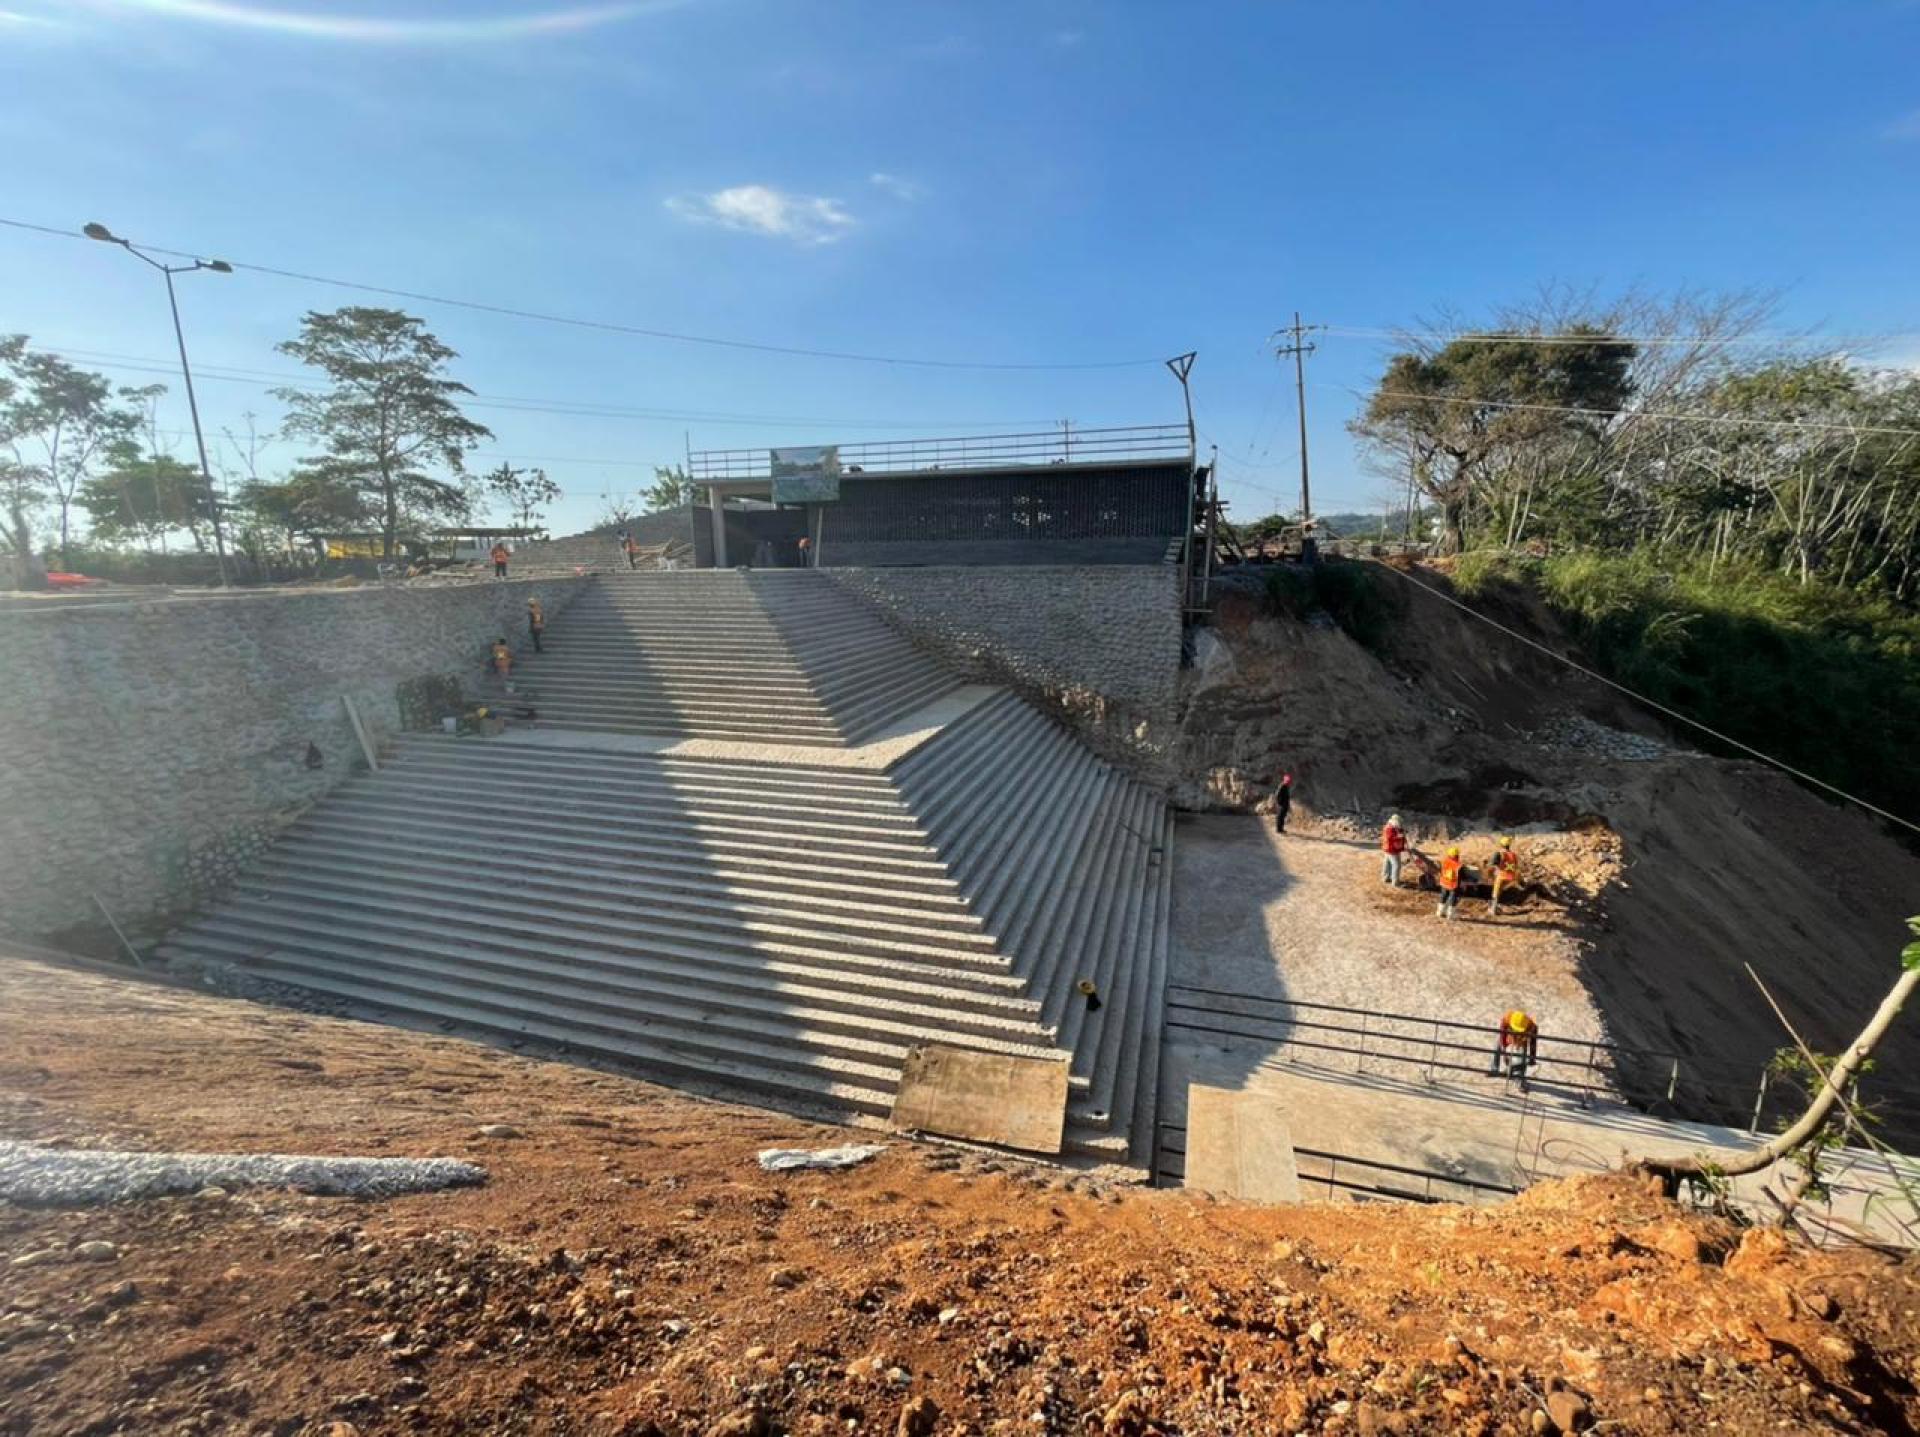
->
{"left": 687, "top": 425, "right": 1190, "bottom": 480}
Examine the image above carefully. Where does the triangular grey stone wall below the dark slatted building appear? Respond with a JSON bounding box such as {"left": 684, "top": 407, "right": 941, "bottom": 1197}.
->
{"left": 820, "top": 565, "right": 1181, "bottom": 790}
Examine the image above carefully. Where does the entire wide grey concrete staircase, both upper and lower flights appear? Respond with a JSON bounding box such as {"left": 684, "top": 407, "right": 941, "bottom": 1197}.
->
{"left": 161, "top": 572, "right": 1171, "bottom": 1166}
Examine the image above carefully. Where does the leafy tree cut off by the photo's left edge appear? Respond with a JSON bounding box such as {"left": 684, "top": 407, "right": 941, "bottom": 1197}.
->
{"left": 0, "top": 334, "right": 140, "bottom": 582}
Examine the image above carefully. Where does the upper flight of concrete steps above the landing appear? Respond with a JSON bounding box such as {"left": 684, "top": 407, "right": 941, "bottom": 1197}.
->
{"left": 515, "top": 569, "right": 960, "bottom": 745}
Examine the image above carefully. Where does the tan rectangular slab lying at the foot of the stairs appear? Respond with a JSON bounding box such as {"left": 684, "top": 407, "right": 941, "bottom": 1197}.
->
{"left": 893, "top": 1043, "right": 1068, "bottom": 1153}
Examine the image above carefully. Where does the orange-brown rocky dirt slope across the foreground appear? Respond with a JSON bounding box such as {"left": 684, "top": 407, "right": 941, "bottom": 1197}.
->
{"left": 11, "top": 961, "right": 1920, "bottom": 1437}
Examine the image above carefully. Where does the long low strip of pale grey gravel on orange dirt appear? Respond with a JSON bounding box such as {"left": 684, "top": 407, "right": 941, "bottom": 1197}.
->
{"left": 0, "top": 1141, "right": 486, "bottom": 1206}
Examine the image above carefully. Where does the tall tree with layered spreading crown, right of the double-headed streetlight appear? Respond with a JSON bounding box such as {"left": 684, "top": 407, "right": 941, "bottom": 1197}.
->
{"left": 276, "top": 305, "right": 492, "bottom": 559}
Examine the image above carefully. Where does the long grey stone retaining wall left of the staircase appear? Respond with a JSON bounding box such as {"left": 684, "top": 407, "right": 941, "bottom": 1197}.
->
{"left": 0, "top": 578, "right": 589, "bottom": 945}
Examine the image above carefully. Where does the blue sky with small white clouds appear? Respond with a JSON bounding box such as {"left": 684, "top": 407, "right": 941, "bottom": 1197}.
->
{"left": 0, "top": 0, "right": 1920, "bottom": 530}
